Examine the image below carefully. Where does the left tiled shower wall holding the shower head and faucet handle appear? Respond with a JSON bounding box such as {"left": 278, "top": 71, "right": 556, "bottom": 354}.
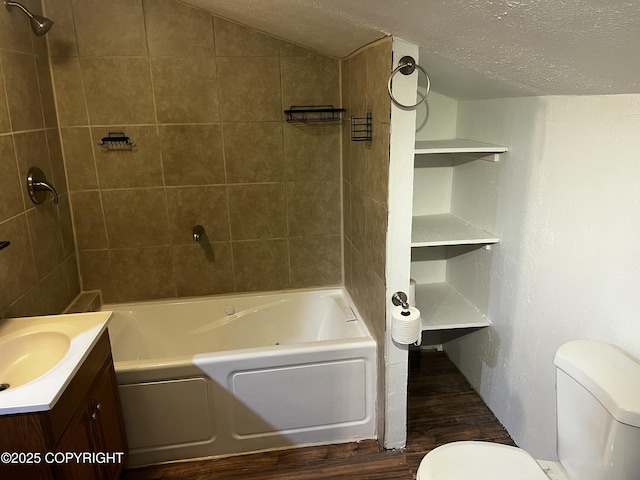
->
{"left": 0, "top": 0, "right": 80, "bottom": 317}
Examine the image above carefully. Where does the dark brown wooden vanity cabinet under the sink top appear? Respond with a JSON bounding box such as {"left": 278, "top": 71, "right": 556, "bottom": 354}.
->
{"left": 0, "top": 332, "right": 127, "bottom": 480}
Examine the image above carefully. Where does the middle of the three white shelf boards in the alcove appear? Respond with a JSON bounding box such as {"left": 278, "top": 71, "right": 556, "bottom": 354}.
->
{"left": 411, "top": 213, "right": 500, "bottom": 247}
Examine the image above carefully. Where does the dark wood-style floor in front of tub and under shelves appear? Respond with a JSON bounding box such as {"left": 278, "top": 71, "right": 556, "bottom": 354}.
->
{"left": 122, "top": 350, "right": 514, "bottom": 480}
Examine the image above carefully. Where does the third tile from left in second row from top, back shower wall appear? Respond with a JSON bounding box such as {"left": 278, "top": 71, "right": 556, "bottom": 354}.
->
{"left": 151, "top": 58, "right": 220, "bottom": 123}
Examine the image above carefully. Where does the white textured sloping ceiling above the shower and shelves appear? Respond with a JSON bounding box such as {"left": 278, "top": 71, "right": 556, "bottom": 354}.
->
{"left": 185, "top": 0, "right": 640, "bottom": 99}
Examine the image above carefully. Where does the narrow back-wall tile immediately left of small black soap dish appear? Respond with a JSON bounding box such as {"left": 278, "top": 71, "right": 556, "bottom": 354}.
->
{"left": 60, "top": 127, "right": 98, "bottom": 191}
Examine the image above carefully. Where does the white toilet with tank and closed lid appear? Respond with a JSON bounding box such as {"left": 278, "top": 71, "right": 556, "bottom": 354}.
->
{"left": 417, "top": 340, "right": 640, "bottom": 480}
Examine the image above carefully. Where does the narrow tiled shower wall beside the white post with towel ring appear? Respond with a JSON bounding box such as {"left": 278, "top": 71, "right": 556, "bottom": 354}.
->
{"left": 342, "top": 38, "right": 392, "bottom": 437}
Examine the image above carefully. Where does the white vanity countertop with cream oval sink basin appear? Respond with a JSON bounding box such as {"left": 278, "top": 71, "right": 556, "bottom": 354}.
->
{"left": 0, "top": 312, "right": 111, "bottom": 415}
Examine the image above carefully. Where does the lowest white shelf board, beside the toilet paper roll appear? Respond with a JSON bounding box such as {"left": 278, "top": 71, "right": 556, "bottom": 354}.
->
{"left": 416, "top": 283, "right": 491, "bottom": 331}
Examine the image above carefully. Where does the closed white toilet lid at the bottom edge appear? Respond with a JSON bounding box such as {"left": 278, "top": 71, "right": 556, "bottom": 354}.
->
{"left": 417, "top": 442, "right": 549, "bottom": 480}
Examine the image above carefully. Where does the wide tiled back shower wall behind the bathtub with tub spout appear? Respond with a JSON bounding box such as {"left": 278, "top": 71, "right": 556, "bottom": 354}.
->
{"left": 46, "top": 0, "right": 342, "bottom": 302}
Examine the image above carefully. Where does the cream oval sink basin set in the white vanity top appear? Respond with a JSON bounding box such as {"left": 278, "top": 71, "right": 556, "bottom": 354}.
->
{"left": 0, "top": 331, "right": 71, "bottom": 390}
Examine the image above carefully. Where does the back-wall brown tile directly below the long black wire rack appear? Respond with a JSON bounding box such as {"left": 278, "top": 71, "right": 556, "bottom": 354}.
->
{"left": 284, "top": 124, "right": 341, "bottom": 181}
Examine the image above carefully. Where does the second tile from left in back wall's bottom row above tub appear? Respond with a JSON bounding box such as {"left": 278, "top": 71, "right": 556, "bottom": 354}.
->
{"left": 109, "top": 247, "right": 176, "bottom": 302}
